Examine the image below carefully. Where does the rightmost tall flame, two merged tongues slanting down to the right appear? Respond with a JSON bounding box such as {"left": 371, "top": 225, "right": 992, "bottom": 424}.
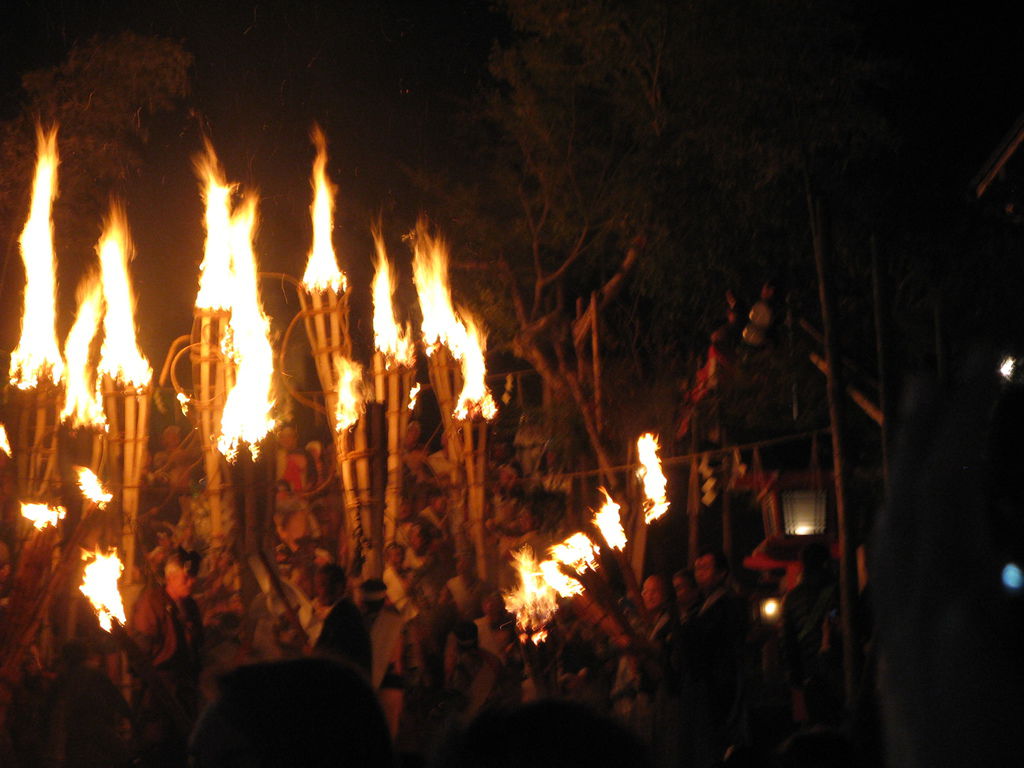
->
{"left": 413, "top": 221, "right": 498, "bottom": 420}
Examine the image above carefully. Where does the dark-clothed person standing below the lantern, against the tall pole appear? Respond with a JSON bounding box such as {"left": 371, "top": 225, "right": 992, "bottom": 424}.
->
{"left": 781, "top": 543, "right": 843, "bottom": 725}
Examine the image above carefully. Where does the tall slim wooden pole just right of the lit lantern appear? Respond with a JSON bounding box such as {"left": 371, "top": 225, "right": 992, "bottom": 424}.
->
{"left": 808, "top": 190, "right": 860, "bottom": 708}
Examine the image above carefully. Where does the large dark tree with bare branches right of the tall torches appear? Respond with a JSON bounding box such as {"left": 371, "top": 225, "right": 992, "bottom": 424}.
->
{"left": 430, "top": 0, "right": 888, "bottom": 475}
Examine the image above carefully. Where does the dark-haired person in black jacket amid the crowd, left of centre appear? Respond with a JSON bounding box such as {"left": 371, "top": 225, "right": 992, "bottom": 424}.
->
{"left": 313, "top": 564, "right": 373, "bottom": 678}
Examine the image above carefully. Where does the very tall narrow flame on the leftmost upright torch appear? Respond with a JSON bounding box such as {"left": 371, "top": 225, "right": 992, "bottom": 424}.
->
{"left": 10, "top": 126, "right": 63, "bottom": 389}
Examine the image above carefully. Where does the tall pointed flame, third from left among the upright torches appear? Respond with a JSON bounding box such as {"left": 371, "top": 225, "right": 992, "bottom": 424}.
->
{"left": 96, "top": 203, "right": 153, "bottom": 389}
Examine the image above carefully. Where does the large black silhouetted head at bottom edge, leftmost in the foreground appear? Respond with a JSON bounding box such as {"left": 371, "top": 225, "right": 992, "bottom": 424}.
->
{"left": 189, "top": 657, "right": 395, "bottom": 768}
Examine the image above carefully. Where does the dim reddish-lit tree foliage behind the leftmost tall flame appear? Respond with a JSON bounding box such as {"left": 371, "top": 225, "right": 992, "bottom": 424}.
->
{"left": 0, "top": 32, "right": 191, "bottom": 319}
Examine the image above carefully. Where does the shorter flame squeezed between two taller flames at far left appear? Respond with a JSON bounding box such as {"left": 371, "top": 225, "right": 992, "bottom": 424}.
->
{"left": 60, "top": 275, "right": 106, "bottom": 429}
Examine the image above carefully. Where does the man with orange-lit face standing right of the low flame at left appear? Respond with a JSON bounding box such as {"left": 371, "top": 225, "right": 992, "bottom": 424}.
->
{"left": 130, "top": 550, "right": 203, "bottom": 766}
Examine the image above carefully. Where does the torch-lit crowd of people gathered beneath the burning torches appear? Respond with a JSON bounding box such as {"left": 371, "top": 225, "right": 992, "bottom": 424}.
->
{"left": 0, "top": 415, "right": 860, "bottom": 766}
